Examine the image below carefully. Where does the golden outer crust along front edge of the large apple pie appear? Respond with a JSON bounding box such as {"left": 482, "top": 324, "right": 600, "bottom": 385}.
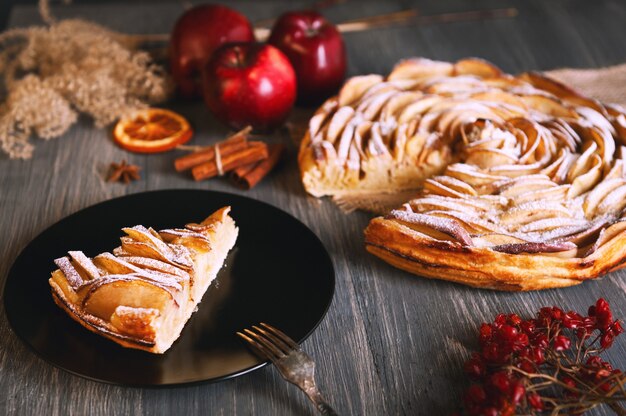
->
{"left": 365, "top": 217, "right": 626, "bottom": 291}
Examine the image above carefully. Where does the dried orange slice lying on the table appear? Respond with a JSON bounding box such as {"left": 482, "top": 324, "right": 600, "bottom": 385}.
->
{"left": 113, "top": 108, "right": 193, "bottom": 153}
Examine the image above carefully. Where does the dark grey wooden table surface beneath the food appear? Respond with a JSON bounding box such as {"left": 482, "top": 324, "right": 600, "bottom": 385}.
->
{"left": 0, "top": 0, "right": 626, "bottom": 415}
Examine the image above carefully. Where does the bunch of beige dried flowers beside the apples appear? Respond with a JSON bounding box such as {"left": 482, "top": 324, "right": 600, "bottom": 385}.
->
{"left": 0, "top": 0, "right": 171, "bottom": 159}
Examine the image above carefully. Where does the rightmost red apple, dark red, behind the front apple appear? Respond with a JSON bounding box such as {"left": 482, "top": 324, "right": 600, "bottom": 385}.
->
{"left": 268, "top": 11, "right": 346, "bottom": 104}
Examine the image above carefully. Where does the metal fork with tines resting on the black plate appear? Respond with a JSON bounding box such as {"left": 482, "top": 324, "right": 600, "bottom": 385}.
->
{"left": 237, "top": 322, "right": 338, "bottom": 416}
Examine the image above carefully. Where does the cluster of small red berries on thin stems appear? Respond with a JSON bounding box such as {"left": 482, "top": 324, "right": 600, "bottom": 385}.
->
{"left": 464, "top": 299, "right": 626, "bottom": 416}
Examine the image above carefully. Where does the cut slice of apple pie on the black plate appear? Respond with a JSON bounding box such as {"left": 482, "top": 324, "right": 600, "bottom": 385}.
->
{"left": 49, "top": 207, "right": 238, "bottom": 353}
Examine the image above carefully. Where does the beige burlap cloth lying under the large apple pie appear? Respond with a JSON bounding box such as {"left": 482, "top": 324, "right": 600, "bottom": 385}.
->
{"left": 310, "top": 64, "right": 626, "bottom": 214}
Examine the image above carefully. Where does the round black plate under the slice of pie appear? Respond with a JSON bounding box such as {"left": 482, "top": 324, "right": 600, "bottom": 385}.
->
{"left": 4, "top": 190, "right": 335, "bottom": 386}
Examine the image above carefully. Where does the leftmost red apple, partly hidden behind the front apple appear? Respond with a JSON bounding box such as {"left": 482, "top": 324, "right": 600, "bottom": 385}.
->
{"left": 169, "top": 4, "right": 254, "bottom": 98}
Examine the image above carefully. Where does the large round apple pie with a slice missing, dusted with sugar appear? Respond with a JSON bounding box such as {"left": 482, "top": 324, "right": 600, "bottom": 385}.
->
{"left": 299, "top": 59, "right": 626, "bottom": 290}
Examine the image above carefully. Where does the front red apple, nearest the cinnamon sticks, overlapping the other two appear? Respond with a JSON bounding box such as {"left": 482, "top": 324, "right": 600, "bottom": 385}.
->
{"left": 202, "top": 42, "right": 296, "bottom": 131}
